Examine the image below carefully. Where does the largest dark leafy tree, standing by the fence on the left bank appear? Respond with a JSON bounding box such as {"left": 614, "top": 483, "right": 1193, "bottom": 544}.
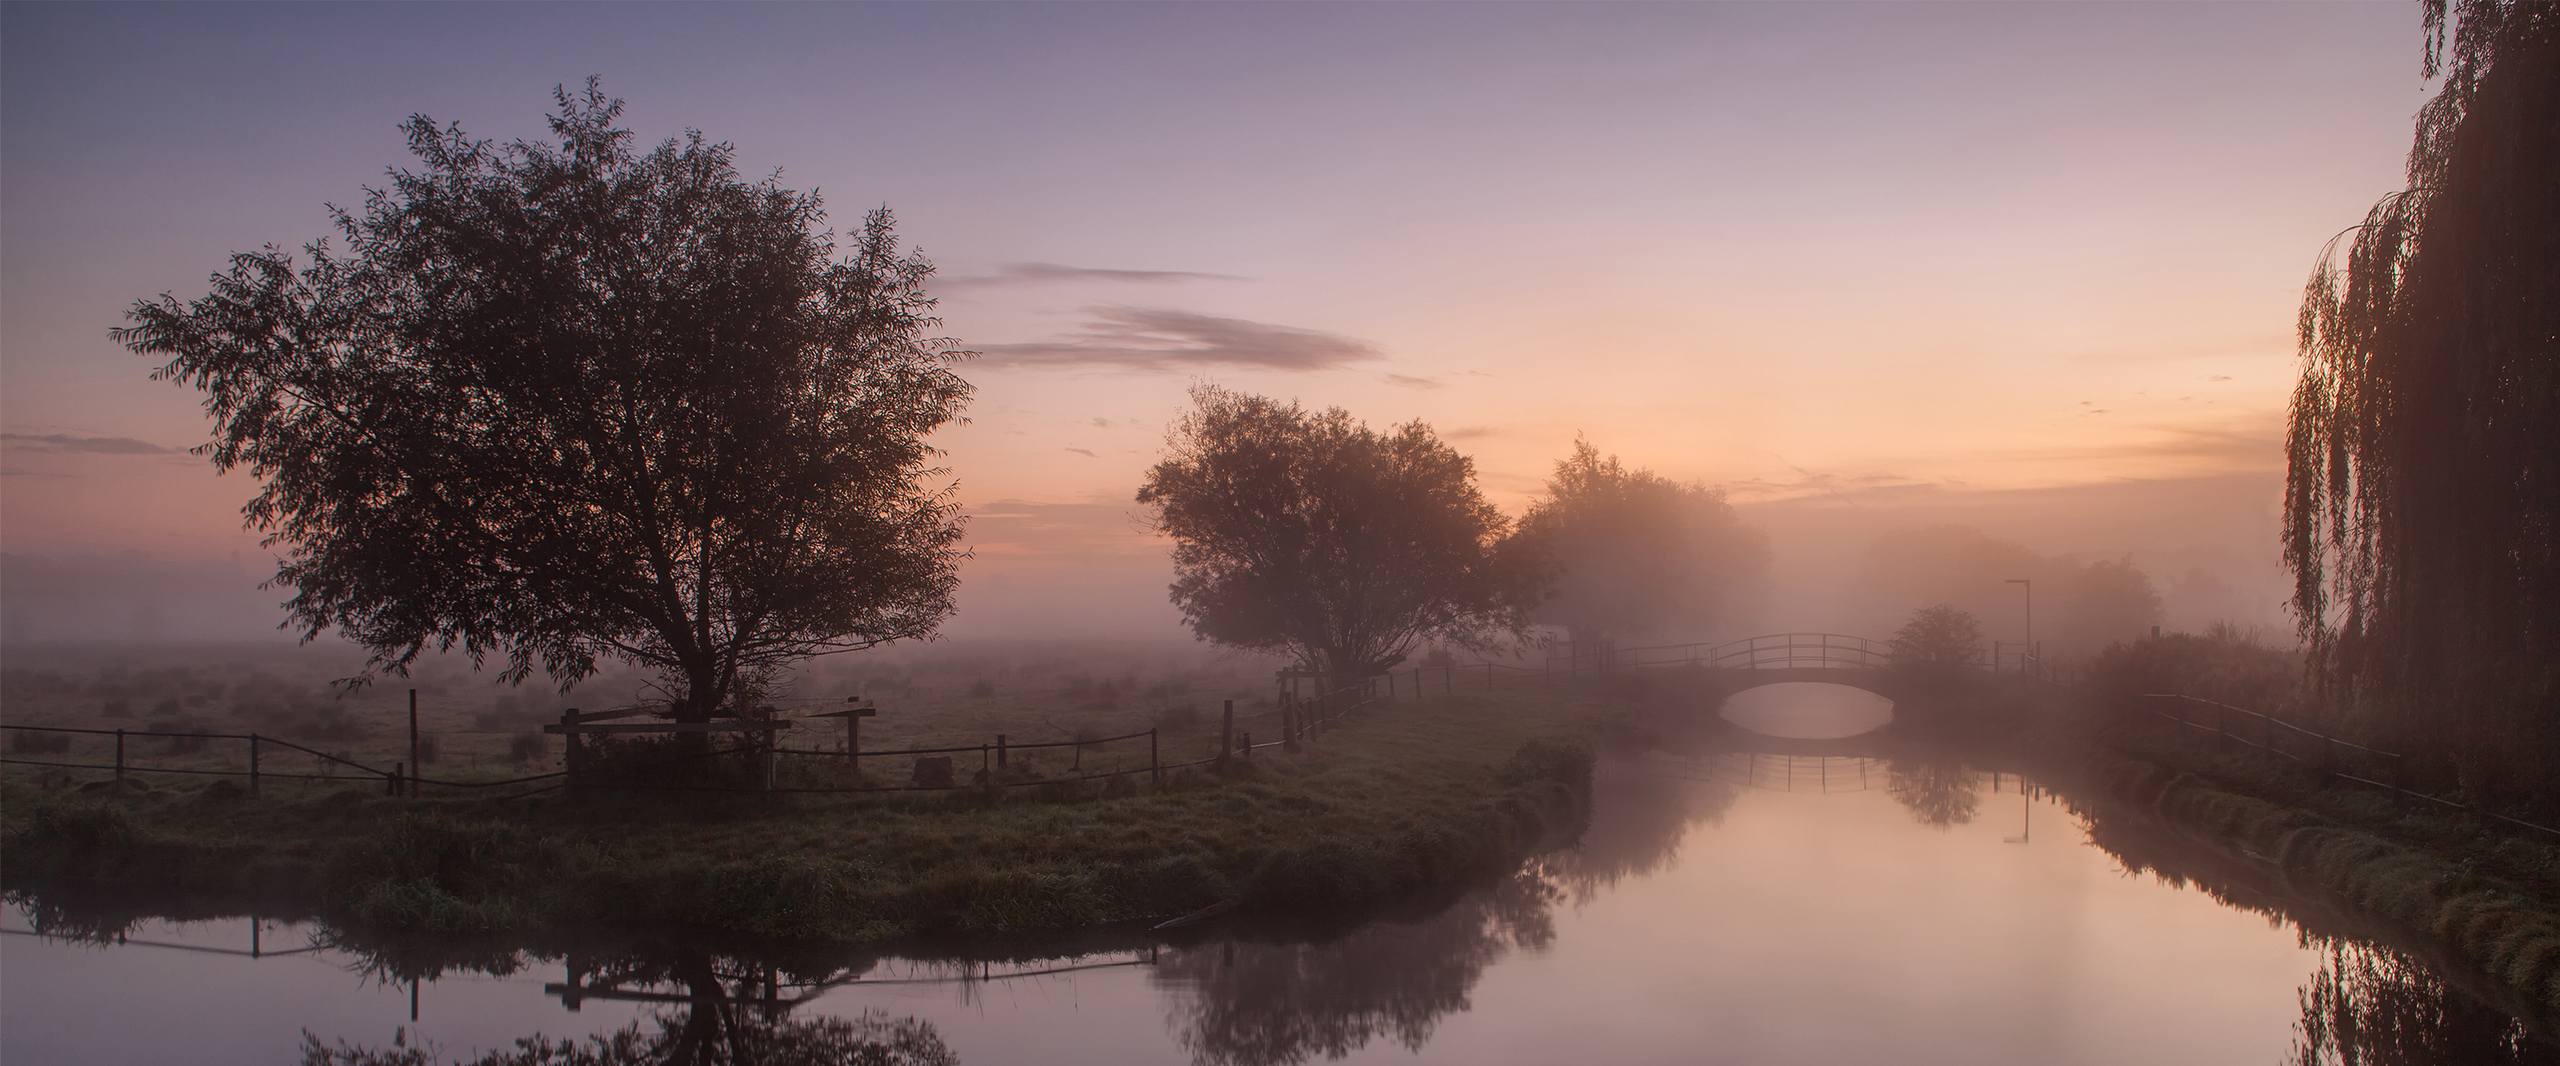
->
{"left": 115, "top": 82, "right": 968, "bottom": 720}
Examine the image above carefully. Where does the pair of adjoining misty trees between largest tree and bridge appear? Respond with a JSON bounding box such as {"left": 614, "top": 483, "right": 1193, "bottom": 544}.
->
{"left": 1137, "top": 387, "right": 1766, "bottom": 684}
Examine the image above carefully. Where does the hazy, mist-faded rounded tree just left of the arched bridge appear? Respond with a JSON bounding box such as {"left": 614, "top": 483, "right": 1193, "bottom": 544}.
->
{"left": 1513, "top": 438, "right": 1769, "bottom": 643}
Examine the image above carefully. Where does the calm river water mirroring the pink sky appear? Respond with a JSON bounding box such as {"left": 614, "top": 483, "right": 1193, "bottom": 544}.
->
{"left": 0, "top": 692, "right": 2560, "bottom": 1066}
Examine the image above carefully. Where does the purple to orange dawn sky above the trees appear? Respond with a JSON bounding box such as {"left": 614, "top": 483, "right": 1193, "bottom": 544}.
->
{"left": 0, "top": 3, "right": 2429, "bottom": 638}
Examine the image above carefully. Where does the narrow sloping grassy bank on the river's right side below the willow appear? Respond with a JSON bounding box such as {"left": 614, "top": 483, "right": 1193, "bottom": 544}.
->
{"left": 2074, "top": 743, "right": 2560, "bottom": 1020}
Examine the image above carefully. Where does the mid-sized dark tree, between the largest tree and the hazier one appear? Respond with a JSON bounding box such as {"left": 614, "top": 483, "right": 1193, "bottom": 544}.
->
{"left": 1137, "top": 387, "right": 1539, "bottom": 682}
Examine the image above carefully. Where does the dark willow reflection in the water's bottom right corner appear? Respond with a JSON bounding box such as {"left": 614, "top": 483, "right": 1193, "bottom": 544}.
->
{"left": 2291, "top": 940, "right": 2560, "bottom": 1066}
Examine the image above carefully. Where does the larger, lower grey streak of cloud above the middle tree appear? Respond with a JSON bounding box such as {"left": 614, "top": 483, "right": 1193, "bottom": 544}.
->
{"left": 978, "top": 305, "right": 1377, "bottom": 372}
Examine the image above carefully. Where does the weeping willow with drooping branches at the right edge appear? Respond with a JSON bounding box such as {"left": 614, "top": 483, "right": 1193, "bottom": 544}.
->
{"left": 2284, "top": 0, "right": 2560, "bottom": 802}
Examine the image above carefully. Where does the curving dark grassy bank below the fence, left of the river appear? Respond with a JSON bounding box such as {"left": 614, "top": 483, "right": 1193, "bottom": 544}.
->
{"left": 0, "top": 692, "right": 1590, "bottom": 943}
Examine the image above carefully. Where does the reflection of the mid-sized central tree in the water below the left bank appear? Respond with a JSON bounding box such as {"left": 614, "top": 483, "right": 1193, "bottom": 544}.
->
{"left": 1155, "top": 864, "right": 1559, "bottom": 1066}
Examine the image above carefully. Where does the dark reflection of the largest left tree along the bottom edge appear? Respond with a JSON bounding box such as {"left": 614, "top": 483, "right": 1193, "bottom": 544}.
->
{"left": 302, "top": 951, "right": 960, "bottom": 1066}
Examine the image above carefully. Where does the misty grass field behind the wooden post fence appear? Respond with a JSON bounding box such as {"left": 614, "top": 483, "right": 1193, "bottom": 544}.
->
{"left": 0, "top": 643, "right": 1423, "bottom": 787}
